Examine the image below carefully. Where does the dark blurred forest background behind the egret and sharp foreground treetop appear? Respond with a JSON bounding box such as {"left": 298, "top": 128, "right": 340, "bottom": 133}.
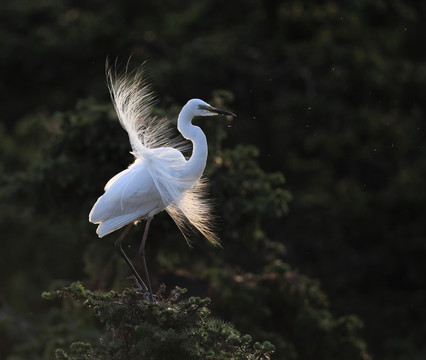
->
{"left": 0, "top": 0, "right": 426, "bottom": 360}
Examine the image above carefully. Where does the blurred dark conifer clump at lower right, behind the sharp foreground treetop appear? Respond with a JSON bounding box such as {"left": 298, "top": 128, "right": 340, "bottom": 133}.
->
{"left": 213, "top": 260, "right": 371, "bottom": 360}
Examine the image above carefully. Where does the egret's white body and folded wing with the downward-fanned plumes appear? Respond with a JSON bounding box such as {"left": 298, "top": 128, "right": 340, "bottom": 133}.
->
{"left": 89, "top": 148, "right": 219, "bottom": 245}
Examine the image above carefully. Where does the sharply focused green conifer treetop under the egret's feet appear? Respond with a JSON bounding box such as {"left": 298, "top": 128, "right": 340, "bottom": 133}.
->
{"left": 43, "top": 283, "right": 275, "bottom": 360}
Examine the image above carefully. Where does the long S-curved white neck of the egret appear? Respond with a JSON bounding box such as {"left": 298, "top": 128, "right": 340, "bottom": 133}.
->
{"left": 177, "top": 107, "right": 208, "bottom": 180}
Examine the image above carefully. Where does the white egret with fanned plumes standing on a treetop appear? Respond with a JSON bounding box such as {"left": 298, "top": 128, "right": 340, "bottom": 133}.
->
{"left": 89, "top": 65, "right": 235, "bottom": 301}
